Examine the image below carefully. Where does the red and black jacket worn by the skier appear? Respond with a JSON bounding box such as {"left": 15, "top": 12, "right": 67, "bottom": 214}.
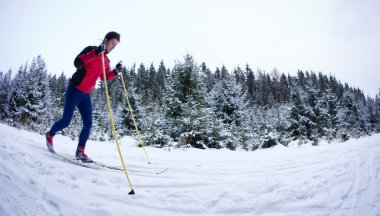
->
{"left": 70, "top": 46, "right": 116, "bottom": 94}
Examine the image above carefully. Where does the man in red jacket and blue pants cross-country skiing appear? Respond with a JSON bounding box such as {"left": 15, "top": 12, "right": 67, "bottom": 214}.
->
{"left": 45, "top": 31, "right": 122, "bottom": 163}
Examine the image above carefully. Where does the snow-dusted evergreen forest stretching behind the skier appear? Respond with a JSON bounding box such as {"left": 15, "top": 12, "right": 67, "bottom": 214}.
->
{"left": 0, "top": 55, "right": 380, "bottom": 151}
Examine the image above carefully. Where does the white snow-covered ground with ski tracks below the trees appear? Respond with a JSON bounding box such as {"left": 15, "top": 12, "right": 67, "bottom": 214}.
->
{"left": 0, "top": 124, "right": 380, "bottom": 216}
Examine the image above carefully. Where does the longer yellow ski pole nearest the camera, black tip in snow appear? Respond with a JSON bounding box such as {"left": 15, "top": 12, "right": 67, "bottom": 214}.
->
{"left": 102, "top": 51, "right": 135, "bottom": 195}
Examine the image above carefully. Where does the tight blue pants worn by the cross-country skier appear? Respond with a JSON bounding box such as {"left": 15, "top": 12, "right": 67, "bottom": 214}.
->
{"left": 49, "top": 84, "right": 92, "bottom": 147}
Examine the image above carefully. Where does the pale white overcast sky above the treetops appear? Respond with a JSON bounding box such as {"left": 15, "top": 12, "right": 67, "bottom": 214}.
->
{"left": 0, "top": 0, "right": 380, "bottom": 97}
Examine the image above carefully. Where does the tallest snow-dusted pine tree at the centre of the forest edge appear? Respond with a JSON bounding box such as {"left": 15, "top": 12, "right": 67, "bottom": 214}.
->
{"left": 166, "top": 55, "right": 207, "bottom": 147}
